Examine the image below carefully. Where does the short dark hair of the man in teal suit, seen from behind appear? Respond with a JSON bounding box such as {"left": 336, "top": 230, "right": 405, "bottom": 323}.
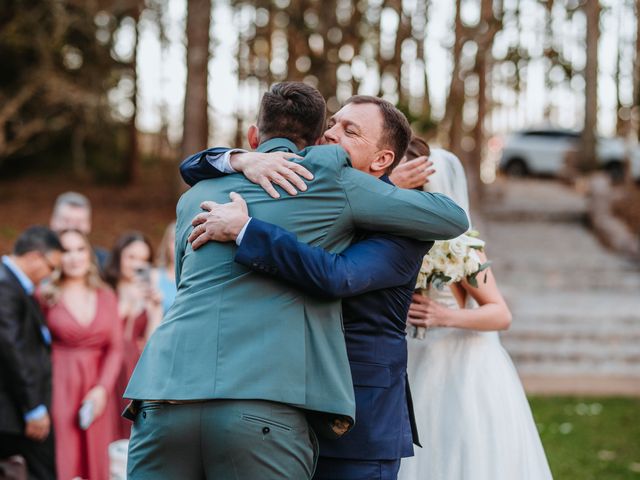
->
{"left": 258, "top": 82, "right": 327, "bottom": 146}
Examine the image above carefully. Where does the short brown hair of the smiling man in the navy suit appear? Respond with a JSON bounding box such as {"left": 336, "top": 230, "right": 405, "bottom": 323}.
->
{"left": 345, "top": 95, "right": 413, "bottom": 171}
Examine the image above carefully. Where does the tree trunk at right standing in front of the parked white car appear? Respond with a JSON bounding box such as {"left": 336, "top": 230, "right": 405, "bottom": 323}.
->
{"left": 581, "top": 0, "right": 600, "bottom": 170}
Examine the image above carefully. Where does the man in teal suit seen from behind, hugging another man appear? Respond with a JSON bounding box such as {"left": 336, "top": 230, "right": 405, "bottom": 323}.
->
{"left": 125, "top": 82, "right": 468, "bottom": 479}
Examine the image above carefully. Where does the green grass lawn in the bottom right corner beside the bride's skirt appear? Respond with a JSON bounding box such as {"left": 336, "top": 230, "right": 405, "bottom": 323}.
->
{"left": 529, "top": 397, "right": 640, "bottom": 480}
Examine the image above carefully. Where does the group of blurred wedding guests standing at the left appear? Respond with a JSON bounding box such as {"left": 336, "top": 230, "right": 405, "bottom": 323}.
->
{"left": 0, "top": 192, "right": 176, "bottom": 480}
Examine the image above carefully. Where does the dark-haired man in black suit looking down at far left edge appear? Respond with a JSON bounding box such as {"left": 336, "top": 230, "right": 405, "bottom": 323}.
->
{"left": 0, "top": 227, "right": 63, "bottom": 479}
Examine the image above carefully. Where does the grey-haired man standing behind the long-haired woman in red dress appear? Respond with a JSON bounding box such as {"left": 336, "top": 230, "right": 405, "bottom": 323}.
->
{"left": 49, "top": 192, "right": 109, "bottom": 270}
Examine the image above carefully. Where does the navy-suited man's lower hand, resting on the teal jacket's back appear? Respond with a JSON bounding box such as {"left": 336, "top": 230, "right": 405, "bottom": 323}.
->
{"left": 189, "top": 192, "right": 249, "bottom": 250}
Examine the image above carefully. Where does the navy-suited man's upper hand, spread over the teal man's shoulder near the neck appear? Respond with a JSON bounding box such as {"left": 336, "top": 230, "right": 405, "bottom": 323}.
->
{"left": 229, "top": 152, "right": 313, "bottom": 198}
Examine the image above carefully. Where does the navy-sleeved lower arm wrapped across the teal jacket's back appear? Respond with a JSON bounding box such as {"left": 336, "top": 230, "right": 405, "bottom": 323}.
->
{"left": 235, "top": 218, "right": 431, "bottom": 298}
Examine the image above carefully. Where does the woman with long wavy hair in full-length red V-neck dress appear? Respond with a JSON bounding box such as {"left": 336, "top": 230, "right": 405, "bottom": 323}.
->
{"left": 39, "top": 230, "right": 122, "bottom": 480}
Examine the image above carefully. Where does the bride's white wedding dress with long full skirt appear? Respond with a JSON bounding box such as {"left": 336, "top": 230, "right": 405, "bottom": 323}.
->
{"left": 398, "top": 287, "right": 552, "bottom": 480}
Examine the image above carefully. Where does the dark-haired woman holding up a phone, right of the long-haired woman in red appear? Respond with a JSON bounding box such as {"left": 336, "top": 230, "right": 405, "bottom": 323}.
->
{"left": 105, "top": 232, "right": 162, "bottom": 438}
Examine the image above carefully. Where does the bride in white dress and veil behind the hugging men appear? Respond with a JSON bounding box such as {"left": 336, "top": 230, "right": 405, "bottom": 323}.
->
{"left": 398, "top": 150, "right": 552, "bottom": 480}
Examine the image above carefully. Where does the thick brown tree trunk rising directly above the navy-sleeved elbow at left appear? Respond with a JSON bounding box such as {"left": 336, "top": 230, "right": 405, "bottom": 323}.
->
{"left": 181, "top": 0, "right": 212, "bottom": 165}
